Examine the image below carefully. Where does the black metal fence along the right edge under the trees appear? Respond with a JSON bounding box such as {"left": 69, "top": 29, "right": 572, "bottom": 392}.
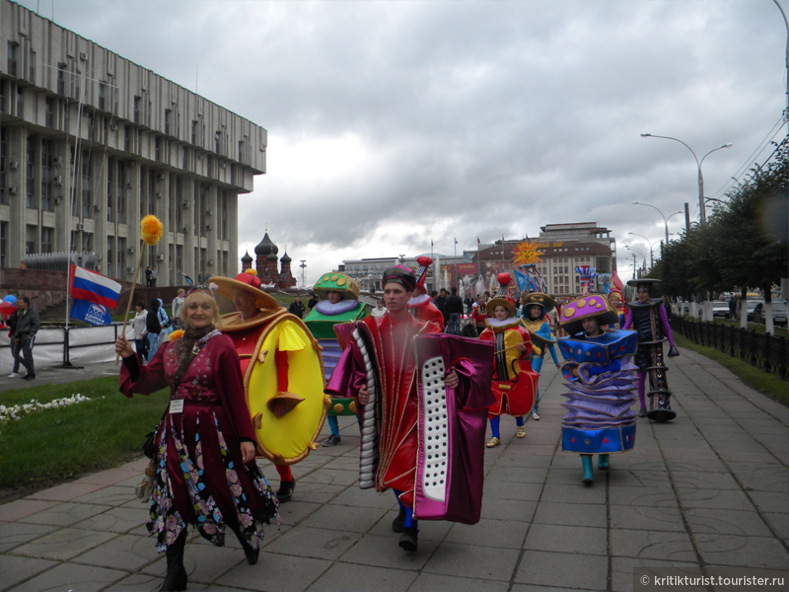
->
{"left": 671, "top": 315, "right": 789, "bottom": 380}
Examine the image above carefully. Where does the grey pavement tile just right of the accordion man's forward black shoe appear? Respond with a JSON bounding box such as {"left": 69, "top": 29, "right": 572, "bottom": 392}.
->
{"left": 422, "top": 542, "right": 520, "bottom": 581}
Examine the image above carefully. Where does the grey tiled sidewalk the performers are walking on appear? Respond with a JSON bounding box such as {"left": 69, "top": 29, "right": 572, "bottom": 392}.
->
{"left": 0, "top": 349, "right": 789, "bottom": 591}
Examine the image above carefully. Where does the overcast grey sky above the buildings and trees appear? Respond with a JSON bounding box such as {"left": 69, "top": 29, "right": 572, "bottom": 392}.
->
{"left": 16, "top": 0, "right": 789, "bottom": 284}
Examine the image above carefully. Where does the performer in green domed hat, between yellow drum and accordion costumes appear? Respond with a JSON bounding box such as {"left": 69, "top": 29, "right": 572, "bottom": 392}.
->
{"left": 304, "top": 272, "right": 368, "bottom": 446}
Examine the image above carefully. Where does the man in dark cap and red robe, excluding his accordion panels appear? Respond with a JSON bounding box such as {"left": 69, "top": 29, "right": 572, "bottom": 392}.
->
{"left": 326, "top": 266, "right": 459, "bottom": 551}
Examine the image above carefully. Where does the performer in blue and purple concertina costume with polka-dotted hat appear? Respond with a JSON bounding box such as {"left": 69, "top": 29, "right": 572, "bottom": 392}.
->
{"left": 559, "top": 294, "right": 638, "bottom": 485}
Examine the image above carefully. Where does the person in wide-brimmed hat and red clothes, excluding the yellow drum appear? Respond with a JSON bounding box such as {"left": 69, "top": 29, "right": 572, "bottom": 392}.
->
{"left": 209, "top": 269, "right": 296, "bottom": 503}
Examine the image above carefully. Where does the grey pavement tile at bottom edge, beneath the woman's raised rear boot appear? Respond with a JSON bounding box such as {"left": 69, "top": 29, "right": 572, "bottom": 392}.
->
{"left": 213, "top": 553, "right": 330, "bottom": 592}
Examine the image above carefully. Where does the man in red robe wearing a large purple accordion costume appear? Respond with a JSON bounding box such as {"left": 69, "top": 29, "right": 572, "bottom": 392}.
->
{"left": 326, "top": 266, "right": 491, "bottom": 551}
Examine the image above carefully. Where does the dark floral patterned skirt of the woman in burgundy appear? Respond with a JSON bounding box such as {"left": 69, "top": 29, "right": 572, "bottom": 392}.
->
{"left": 147, "top": 401, "right": 279, "bottom": 553}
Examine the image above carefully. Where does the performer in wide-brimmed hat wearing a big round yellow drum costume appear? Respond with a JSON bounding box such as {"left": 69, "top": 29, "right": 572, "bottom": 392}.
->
{"left": 208, "top": 269, "right": 325, "bottom": 503}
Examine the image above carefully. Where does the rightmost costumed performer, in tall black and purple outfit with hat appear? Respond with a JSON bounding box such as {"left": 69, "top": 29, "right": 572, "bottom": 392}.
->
{"left": 622, "top": 278, "right": 679, "bottom": 422}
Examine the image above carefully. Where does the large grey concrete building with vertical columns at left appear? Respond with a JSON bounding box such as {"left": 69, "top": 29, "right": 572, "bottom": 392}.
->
{"left": 0, "top": 0, "right": 267, "bottom": 286}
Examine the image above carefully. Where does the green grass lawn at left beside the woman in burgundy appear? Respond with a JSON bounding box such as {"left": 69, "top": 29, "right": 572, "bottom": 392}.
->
{"left": 0, "top": 377, "right": 168, "bottom": 502}
